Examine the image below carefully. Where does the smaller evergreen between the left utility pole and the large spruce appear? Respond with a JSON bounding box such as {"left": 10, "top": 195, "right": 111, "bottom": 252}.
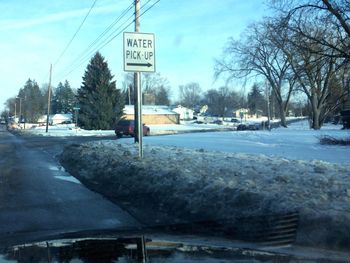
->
{"left": 52, "top": 80, "right": 77, "bottom": 113}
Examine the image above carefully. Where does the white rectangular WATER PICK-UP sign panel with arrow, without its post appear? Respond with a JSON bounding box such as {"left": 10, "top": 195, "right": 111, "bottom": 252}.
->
{"left": 124, "top": 32, "right": 156, "bottom": 72}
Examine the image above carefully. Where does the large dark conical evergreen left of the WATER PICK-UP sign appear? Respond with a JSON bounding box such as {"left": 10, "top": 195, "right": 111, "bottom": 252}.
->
{"left": 78, "top": 52, "right": 124, "bottom": 130}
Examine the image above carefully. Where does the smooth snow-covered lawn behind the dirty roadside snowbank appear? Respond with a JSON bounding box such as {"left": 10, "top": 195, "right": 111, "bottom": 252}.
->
{"left": 120, "top": 121, "right": 350, "bottom": 164}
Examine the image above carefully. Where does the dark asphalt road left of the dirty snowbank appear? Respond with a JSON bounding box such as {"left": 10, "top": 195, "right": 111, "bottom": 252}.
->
{"left": 0, "top": 126, "right": 139, "bottom": 244}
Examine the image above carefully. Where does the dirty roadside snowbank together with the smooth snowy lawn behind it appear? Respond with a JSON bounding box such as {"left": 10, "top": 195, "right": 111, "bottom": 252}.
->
{"left": 61, "top": 121, "right": 350, "bottom": 250}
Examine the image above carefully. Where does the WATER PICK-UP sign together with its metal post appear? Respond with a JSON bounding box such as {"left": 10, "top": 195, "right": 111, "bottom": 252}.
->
{"left": 123, "top": 32, "right": 156, "bottom": 158}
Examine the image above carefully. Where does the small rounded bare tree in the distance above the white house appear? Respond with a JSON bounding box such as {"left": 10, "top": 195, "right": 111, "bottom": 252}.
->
{"left": 179, "top": 82, "right": 202, "bottom": 108}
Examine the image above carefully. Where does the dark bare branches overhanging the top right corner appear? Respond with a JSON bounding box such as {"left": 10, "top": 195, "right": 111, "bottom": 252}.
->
{"left": 270, "top": 0, "right": 350, "bottom": 61}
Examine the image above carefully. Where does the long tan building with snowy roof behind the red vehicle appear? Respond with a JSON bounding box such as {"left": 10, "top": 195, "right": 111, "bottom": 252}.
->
{"left": 124, "top": 105, "right": 180, "bottom": 125}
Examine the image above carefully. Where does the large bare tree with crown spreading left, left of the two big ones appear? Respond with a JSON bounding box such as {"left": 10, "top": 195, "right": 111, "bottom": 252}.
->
{"left": 214, "top": 19, "right": 294, "bottom": 127}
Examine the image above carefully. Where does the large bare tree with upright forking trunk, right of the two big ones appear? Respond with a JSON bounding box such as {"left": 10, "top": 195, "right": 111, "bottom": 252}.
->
{"left": 268, "top": 10, "right": 347, "bottom": 129}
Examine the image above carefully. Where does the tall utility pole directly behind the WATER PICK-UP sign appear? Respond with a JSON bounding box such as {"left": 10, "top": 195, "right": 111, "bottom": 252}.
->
{"left": 134, "top": 0, "right": 142, "bottom": 143}
